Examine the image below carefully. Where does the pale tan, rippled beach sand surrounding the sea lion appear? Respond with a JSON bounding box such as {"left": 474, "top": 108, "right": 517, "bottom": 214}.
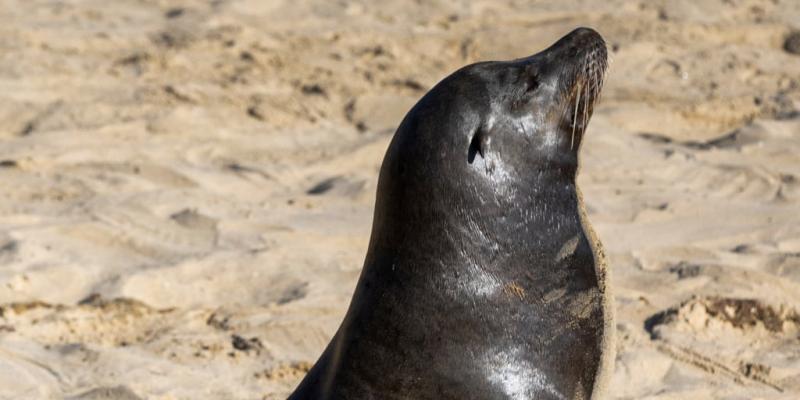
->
{"left": 0, "top": 0, "right": 800, "bottom": 399}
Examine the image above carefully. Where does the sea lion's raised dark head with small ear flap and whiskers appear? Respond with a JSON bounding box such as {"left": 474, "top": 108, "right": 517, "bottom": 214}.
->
{"left": 378, "top": 28, "right": 607, "bottom": 227}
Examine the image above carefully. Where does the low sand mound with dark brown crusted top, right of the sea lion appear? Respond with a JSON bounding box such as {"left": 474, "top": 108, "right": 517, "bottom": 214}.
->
{"left": 645, "top": 297, "right": 800, "bottom": 393}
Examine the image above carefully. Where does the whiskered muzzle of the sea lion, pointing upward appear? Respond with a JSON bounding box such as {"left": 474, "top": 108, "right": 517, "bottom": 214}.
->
{"left": 552, "top": 28, "right": 608, "bottom": 150}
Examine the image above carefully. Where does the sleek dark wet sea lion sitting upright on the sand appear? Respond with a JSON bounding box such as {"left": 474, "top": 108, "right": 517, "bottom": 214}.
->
{"left": 289, "top": 28, "right": 614, "bottom": 400}
